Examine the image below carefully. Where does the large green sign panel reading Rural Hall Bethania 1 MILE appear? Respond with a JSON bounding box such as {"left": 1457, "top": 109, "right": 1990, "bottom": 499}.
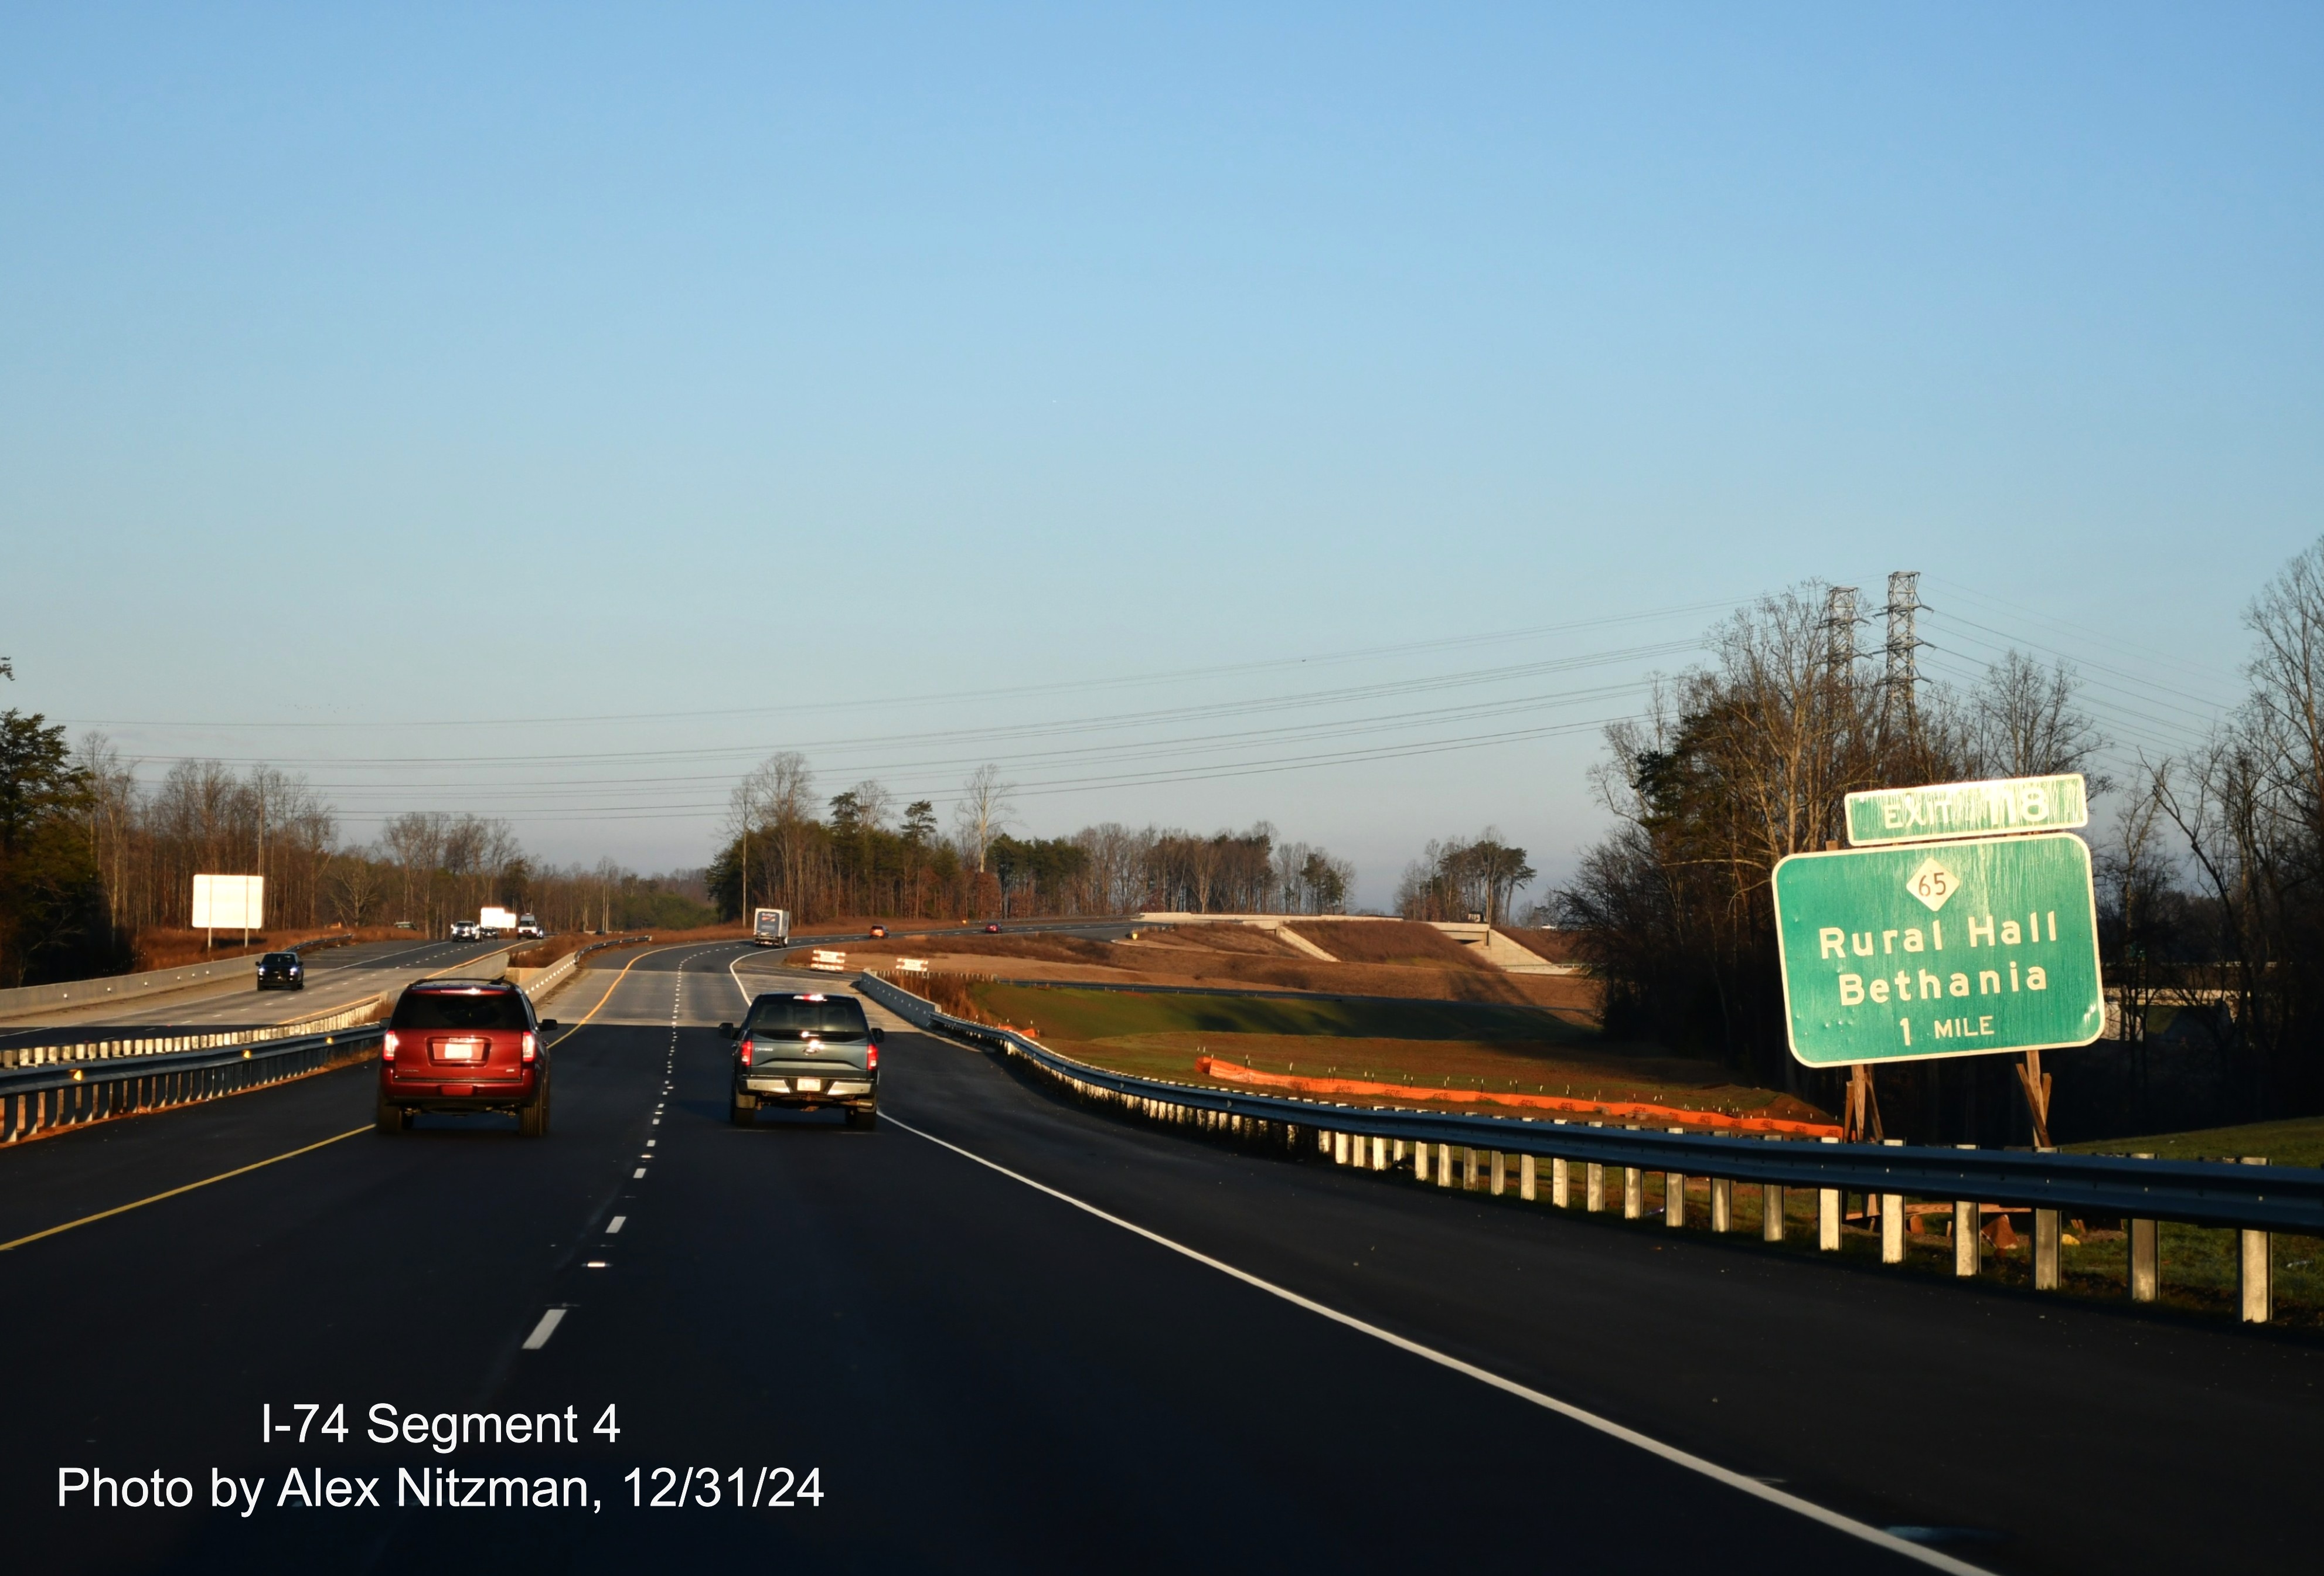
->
{"left": 1776, "top": 832, "right": 2105, "bottom": 1067}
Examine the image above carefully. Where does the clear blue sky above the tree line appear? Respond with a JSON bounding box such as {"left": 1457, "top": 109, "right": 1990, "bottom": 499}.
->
{"left": 0, "top": 5, "right": 2324, "bottom": 902}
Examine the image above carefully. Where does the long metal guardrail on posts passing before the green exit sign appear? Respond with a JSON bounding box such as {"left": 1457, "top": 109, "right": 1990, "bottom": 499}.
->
{"left": 857, "top": 974, "right": 2324, "bottom": 1323}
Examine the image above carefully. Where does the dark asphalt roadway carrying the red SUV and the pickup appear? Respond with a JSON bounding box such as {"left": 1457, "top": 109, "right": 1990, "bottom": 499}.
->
{"left": 0, "top": 944, "right": 2324, "bottom": 1571}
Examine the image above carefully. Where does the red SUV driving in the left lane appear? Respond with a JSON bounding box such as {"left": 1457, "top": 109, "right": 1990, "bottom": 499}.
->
{"left": 379, "top": 979, "right": 558, "bottom": 1139}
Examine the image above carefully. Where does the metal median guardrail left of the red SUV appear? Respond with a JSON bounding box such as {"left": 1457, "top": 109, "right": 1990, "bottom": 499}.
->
{"left": 0, "top": 1023, "right": 386, "bottom": 1143}
